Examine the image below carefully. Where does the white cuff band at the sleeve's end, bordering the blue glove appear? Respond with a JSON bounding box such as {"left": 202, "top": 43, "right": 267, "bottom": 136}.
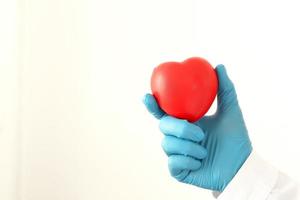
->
{"left": 214, "top": 152, "right": 279, "bottom": 200}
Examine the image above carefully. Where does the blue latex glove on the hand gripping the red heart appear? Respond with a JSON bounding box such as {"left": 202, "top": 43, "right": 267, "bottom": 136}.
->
{"left": 144, "top": 65, "right": 252, "bottom": 191}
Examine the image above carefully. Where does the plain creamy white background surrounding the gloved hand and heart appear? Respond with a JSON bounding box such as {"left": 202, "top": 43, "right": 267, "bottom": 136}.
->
{"left": 0, "top": 0, "right": 300, "bottom": 200}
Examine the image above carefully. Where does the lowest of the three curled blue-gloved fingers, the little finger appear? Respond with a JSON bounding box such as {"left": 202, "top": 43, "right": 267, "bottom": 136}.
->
{"left": 168, "top": 155, "right": 201, "bottom": 177}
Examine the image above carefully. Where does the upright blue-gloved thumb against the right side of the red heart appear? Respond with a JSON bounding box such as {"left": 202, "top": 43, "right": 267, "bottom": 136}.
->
{"left": 216, "top": 65, "right": 238, "bottom": 111}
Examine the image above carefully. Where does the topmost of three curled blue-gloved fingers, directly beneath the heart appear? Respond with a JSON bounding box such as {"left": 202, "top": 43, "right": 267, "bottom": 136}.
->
{"left": 159, "top": 116, "right": 204, "bottom": 142}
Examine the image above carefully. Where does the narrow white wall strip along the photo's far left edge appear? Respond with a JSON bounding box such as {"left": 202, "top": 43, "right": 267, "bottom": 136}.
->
{"left": 0, "top": 1, "right": 19, "bottom": 200}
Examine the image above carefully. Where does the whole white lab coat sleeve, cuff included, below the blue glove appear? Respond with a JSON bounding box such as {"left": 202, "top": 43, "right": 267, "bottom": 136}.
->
{"left": 213, "top": 152, "right": 300, "bottom": 200}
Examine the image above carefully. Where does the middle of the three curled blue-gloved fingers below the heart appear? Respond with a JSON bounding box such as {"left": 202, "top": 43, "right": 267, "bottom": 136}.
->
{"left": 161, "top": 136, "right": 207, "bottom": 159}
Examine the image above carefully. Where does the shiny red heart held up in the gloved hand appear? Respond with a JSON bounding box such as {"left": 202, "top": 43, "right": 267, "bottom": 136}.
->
{"left": 151, "top": 57, "right": 218, "bottom": 122}
